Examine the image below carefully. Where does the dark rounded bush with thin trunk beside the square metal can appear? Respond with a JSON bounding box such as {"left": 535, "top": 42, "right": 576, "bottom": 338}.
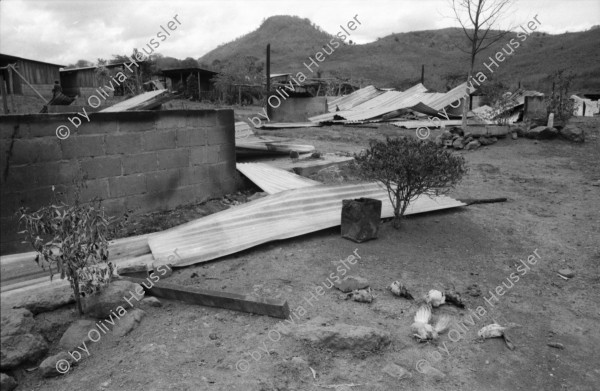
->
{"left": 355, "top": 137, "right": 467, "bottom": 228}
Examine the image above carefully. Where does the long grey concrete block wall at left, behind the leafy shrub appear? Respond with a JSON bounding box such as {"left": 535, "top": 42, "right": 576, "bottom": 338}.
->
{"left": 0, "top": 109, "right": 237, "bottom": 254}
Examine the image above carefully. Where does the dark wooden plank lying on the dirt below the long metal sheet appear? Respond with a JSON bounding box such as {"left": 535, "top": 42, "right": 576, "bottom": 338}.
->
{"left": 121, "top": 277, "right": 290, "bottom": 319}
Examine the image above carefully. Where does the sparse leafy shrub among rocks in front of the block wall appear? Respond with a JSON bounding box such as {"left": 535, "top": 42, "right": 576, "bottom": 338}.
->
{"left": 17, "top": 191, "right": 122, "bottom": 314}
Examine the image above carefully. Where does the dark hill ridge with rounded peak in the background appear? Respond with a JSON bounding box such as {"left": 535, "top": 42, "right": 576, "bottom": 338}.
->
{"left": 199, "top": 16, "right": 600, "bottom": 92}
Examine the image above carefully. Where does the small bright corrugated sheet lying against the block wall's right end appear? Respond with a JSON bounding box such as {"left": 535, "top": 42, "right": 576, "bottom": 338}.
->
{"left": 235, "top": 163, "right": 322, "bottom": 194}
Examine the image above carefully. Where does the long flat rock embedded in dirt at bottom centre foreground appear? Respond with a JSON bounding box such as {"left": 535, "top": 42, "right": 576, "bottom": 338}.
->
{"left": 280, "top": 317, "right": 391, "bottom": 351}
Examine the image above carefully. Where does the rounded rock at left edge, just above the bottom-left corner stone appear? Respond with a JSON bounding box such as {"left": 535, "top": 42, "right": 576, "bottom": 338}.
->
{"left": 0, "top": 333, "right": 48, "bottom": 369}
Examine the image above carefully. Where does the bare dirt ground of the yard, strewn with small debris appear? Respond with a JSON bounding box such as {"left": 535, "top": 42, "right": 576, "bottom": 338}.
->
{"left": 9, "top": 114, "right": 600, "bottom": 391}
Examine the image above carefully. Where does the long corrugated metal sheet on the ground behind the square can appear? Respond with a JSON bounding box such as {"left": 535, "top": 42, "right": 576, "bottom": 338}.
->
{"left": 149, "top": 183, "right": 465, "bottom": 266}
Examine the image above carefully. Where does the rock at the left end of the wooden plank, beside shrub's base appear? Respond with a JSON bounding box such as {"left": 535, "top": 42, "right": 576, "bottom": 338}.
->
{"left": 82, "top": 280, "right": 144, "bottom": 319}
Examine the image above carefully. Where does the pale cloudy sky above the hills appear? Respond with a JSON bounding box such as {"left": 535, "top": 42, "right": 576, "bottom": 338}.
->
{"left": 0, "top": 0, "right": 600, "bottom": 65}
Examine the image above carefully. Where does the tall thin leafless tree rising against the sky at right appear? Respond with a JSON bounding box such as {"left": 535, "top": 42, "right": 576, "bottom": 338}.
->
{"left": 452, "top": 0, "right": 511, "bottom": 129}
